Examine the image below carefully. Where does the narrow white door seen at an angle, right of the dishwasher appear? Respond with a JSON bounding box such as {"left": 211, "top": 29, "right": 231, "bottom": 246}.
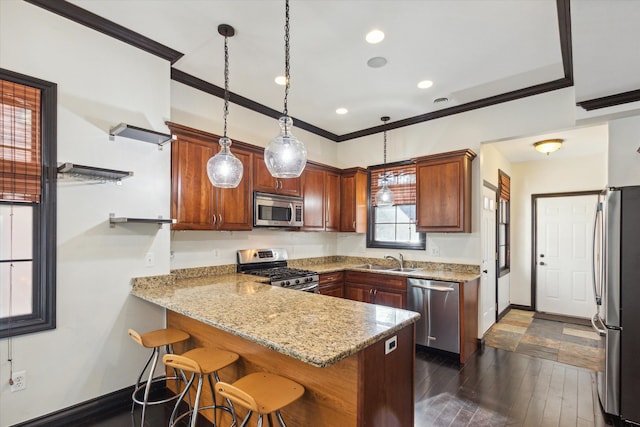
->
{"left": 480, "top": 187, "right": 496, "bottom": 336}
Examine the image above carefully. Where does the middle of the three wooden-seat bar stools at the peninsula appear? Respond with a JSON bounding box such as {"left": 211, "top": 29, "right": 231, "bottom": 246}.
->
{"left": 162, "top": 347, "right": 239, "bottom": 427}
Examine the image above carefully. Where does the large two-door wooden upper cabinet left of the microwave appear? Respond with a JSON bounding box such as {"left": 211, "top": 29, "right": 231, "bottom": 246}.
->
{"left": 167, "top": 123, "right": 253, "bottom": 230}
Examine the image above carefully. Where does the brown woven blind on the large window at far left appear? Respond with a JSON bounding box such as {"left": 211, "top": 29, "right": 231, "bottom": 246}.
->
{"left": 0, "top": 80, "right": 42, "bottom": 202}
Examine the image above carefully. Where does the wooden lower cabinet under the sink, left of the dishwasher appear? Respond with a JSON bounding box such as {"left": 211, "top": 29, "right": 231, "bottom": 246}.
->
{"left": 344, "top": 271, "right": 407, "bottom": 308}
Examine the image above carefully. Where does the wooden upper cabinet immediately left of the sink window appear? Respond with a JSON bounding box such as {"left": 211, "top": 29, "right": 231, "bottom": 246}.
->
{"left": 340, "top": 168, "right": 368, "bottom": 233}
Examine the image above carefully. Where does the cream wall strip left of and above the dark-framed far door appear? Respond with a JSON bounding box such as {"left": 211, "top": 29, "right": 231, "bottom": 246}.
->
{"left": 510, "top": 154, "right": 607, "bottom": 306}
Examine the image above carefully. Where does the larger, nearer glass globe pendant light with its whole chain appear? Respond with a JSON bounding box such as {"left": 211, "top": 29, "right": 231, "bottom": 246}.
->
{"left": 264, "top": 0, "right": 307, "bottom": 178}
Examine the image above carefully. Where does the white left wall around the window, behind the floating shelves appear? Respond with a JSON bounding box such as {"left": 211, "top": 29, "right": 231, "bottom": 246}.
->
{"left": 0, "top": 0, "right": 170, "bottom": 427}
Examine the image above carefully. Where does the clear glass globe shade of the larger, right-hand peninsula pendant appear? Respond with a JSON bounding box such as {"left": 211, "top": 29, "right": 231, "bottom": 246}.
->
{"left": 264, "top": 116, "right": 307, "bottom": 178}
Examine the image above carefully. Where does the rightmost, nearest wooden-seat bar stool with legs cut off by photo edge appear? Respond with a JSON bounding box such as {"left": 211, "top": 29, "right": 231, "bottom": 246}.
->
{"left": 216, "top": 372, "right": 304, "bottom": 427}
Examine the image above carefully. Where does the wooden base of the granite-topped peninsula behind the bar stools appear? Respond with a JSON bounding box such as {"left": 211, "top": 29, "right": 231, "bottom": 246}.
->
{"left": 167, "top": 310, "right": 415, "bottom": 427}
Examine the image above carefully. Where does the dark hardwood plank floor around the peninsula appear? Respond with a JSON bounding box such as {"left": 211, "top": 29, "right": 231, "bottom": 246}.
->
{"left": 75, "top": 347, "right": 614, "bottom": 427}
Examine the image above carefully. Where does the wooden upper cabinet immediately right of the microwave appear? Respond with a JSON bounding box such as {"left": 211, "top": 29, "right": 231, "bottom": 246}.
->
{"left": 301, "top": 164, "right": 340, "bottom": 231}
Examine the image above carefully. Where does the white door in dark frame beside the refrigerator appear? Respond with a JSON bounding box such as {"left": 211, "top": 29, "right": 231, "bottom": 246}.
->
{"left": 535, "top": 195, "right": 598, "bottom": 318}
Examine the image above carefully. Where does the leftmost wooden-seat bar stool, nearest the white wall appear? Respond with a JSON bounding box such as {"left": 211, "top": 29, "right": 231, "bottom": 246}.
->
{"left": 129, "top": 328, "right": 190, "bottom": 426}
